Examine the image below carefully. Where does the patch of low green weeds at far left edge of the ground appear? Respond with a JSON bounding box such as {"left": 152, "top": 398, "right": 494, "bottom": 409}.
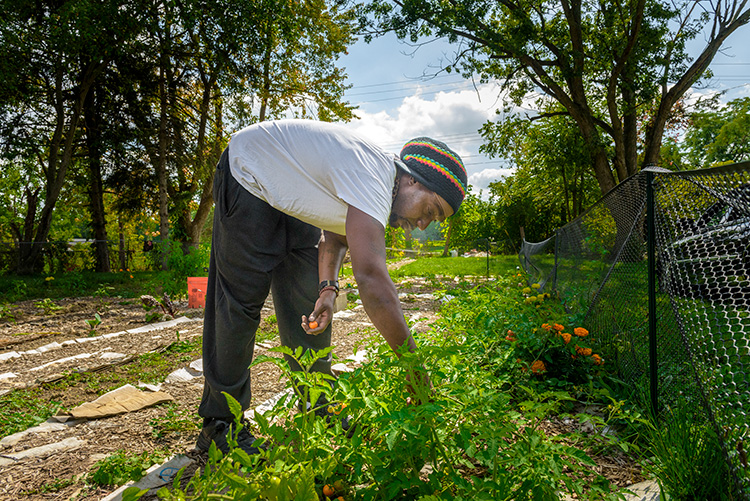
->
{"left": 0, "top": 389, "right": 60, "bottom": 437}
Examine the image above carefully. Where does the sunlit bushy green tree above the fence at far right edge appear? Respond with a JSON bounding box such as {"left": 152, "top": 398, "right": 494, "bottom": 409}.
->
{"left": 684, "top": 96, "right": 750, "bottom": 167}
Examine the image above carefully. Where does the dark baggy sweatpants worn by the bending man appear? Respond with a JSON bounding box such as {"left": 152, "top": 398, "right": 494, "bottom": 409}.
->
{"left": 198, "top": 150, "right": 331, "bottom": 419}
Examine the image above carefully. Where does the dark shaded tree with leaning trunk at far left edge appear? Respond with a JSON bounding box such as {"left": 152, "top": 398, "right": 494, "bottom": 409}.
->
{"left": 0, "top": 0, "right": 145, "bottom": 273}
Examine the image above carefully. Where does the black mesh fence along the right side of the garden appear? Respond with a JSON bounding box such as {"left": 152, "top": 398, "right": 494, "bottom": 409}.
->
{"left": 520, "top": 162, "right": 750, "bottom": 499}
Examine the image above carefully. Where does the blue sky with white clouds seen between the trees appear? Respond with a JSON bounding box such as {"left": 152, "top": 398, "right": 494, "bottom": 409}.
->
{"left": 339, "top": 25, "right": 750, "bottom": 194}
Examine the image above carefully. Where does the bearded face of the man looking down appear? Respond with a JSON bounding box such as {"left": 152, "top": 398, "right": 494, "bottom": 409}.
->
{"left": 388, "top": 175, "right": 453, "bottom": 233}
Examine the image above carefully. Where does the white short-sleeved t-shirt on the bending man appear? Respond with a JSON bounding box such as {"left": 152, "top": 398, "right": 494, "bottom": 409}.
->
{"left": 229, "top": 120, "right": 397, "bottom": 235}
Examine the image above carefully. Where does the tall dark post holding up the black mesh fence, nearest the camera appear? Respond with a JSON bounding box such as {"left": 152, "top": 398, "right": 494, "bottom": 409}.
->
{"left": 646, "top": 171, "right": 659, "bottom": 416}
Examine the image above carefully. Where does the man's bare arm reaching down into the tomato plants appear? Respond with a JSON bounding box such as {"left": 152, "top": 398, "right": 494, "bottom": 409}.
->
{"left": 346, "top": 206, "right": 417, "bottom": 351}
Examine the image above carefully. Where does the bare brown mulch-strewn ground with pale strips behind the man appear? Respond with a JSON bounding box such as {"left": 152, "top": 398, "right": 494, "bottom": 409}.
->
{"left": 0, "top": 272, "right": 640, "bottom": 500}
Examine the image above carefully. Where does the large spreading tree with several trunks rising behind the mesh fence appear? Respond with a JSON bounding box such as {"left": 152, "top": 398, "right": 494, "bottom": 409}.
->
{"left": 371, "top": 0, "right": 750, "bottom": 194}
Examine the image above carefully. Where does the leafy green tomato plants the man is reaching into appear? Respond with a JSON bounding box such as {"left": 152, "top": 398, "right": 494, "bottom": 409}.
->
{"left": 151, "top": 270, "right": 640, "bottom": 501}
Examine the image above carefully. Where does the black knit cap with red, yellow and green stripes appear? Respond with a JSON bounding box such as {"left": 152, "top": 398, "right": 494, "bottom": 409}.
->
{"left": 401, "top": 137, "right": 466, "bottom": 213}
